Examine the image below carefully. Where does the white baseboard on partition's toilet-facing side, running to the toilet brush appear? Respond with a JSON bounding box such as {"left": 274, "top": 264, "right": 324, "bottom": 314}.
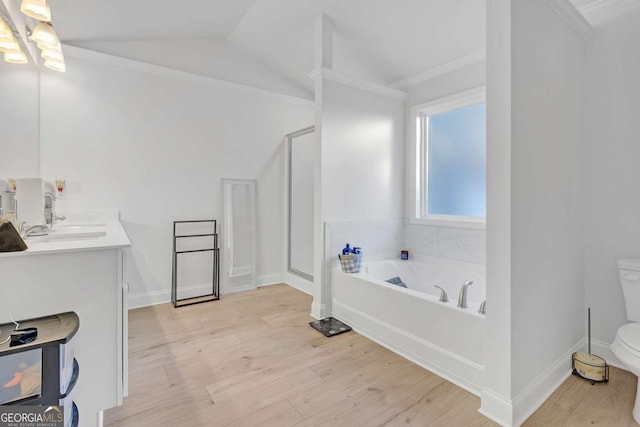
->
{"left": 513, "top": 338, "right": 587, "bottom": 426}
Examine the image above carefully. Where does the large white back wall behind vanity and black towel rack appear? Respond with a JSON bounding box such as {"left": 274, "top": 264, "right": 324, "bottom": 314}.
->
{"left": 41, "top": 58, "right": 313, "bottom": 302}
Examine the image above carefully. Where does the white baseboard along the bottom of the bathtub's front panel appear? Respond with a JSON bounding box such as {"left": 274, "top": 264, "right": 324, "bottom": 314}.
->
{"left": 332, "top": 300, "right": 484, "bottom": 396}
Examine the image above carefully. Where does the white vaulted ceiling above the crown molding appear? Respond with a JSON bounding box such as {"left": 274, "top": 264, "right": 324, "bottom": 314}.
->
{"left": 3, "top": 0, "right": 602, "bottom": 99}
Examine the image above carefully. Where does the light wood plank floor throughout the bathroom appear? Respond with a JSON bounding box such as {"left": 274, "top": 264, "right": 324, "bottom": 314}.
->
{"left": 105, "top": 285, "right": 635, "bottom": 427}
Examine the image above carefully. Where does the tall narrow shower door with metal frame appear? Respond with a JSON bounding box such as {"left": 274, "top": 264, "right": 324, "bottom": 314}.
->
{"left": 287, "top": 126, "right": 315, "bottom": 281}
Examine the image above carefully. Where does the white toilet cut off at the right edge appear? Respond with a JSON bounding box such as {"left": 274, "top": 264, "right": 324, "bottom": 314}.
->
{"left": 611, "top": 259, "right": 640, "bottom": 423}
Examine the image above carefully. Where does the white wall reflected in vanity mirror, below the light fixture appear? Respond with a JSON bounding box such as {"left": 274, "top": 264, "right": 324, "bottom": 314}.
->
{"left": 0, "top": 61, "right": 38, "bottom": 180}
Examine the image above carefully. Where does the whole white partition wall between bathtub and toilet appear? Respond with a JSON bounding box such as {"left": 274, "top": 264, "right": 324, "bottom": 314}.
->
{"left": 482, "top": 0, "right": 586, "bottom": 425}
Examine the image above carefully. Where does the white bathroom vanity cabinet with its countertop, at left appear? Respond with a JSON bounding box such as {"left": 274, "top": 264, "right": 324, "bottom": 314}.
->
{"left": 0, "top": 215, "right": 131, "bottom": 426}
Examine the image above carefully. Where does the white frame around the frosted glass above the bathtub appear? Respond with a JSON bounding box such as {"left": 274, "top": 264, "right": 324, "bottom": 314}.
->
{"left": 409, "top": 86, "right": 486, "bottom": 229}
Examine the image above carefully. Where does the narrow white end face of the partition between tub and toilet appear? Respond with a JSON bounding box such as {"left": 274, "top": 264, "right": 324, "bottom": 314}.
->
{"left": 480, "top": 0, "right": 513, "bottom": 425}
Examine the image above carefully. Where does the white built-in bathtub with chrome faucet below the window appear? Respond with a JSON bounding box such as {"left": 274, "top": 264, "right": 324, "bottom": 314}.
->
{"left": 332, "top": 257, "right": 491, "bottom": 395}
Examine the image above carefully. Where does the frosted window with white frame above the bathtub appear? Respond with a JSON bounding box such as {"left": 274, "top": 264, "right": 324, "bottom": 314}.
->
{"left": 413, "top": 88, "right": 487, "bottom": 226}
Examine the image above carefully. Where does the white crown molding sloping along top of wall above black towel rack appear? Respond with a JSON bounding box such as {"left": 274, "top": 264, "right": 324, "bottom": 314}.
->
{"left": 62, "top": 44, "right": 314, "bottom": 107}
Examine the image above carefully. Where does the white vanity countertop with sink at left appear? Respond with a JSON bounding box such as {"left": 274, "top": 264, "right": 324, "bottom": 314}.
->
{"left": 0, "top": 219, "right": 131, "bottom": 258}
